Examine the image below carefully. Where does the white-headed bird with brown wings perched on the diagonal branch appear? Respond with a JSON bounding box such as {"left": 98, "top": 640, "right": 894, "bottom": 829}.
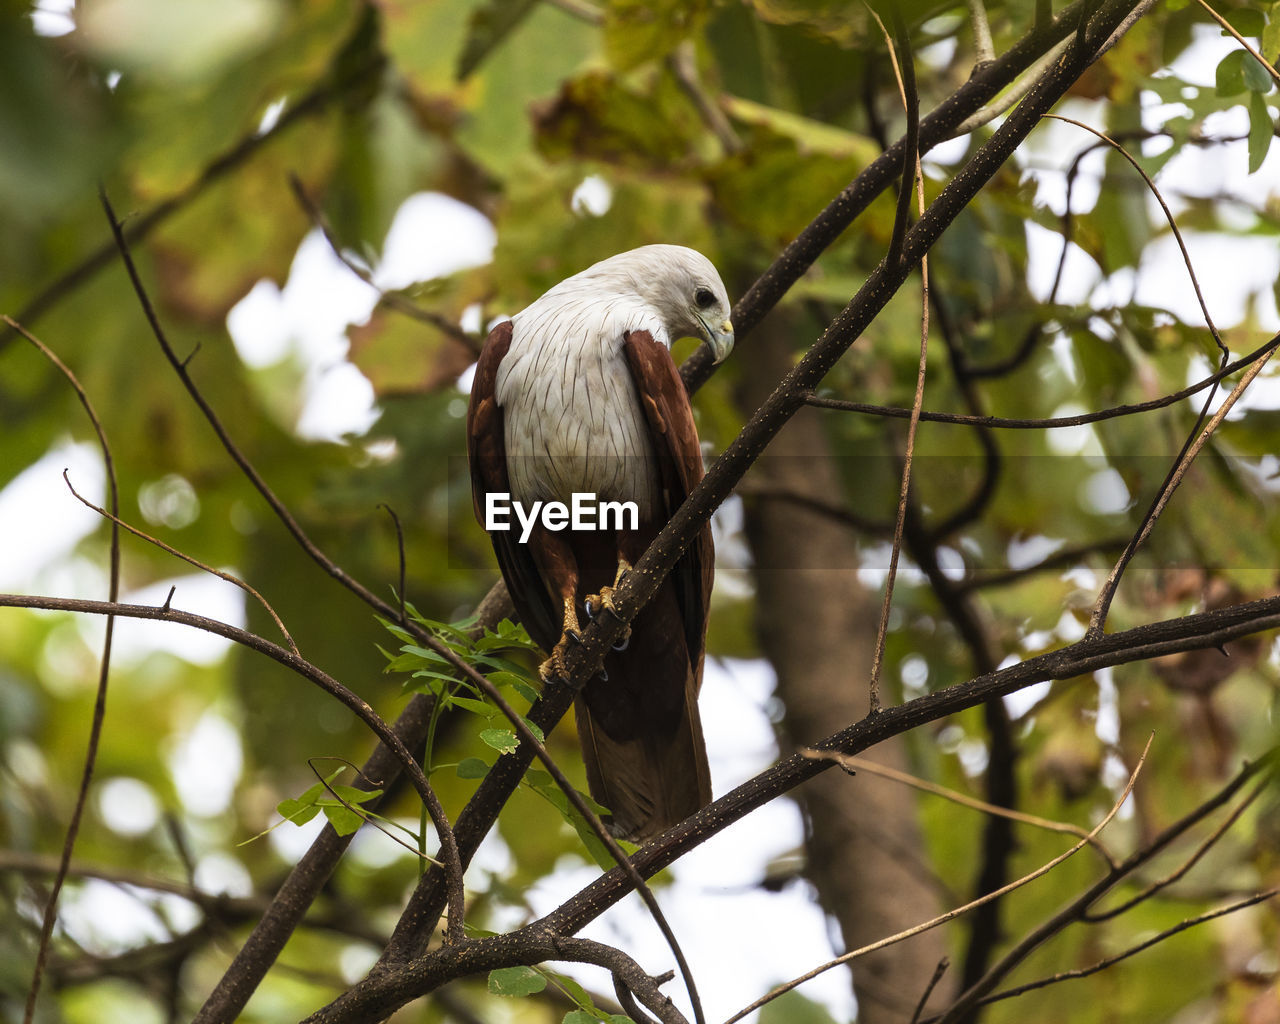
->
{"left": 467, "top": 244, "right": 733, "bottom": 842}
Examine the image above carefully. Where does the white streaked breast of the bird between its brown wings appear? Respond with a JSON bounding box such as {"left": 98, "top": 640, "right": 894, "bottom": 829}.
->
{"left": 494, "top": 294, "right": 668, "bottom": 517}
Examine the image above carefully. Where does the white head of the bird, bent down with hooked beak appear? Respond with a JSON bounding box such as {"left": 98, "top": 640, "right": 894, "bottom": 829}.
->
{"left": 570, "top": 246, "right": 733, "bottom": 362}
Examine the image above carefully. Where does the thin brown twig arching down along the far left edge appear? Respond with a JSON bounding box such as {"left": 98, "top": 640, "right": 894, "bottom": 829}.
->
{"left": 3, "top": 316, "right": 120, "bottom": 1024}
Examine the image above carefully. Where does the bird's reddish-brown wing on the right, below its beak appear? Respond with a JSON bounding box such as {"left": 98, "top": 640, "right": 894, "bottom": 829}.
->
{"left": 623, "top": 330, "right": 716, "bottom": 686}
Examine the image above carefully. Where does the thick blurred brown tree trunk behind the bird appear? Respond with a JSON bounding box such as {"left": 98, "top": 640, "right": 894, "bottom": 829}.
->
{"left": 742, "top": 324, "right": 947, "bottom": 1024}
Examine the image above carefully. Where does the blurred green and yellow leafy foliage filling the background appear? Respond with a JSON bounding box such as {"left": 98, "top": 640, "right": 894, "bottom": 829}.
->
{"left": 0, "top": 0, "right": 1280, "bottom": 1024}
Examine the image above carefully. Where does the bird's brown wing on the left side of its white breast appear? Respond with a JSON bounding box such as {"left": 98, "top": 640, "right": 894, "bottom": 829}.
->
{"left": 467, "top": 320, "right": 561, "bottom": 650}
